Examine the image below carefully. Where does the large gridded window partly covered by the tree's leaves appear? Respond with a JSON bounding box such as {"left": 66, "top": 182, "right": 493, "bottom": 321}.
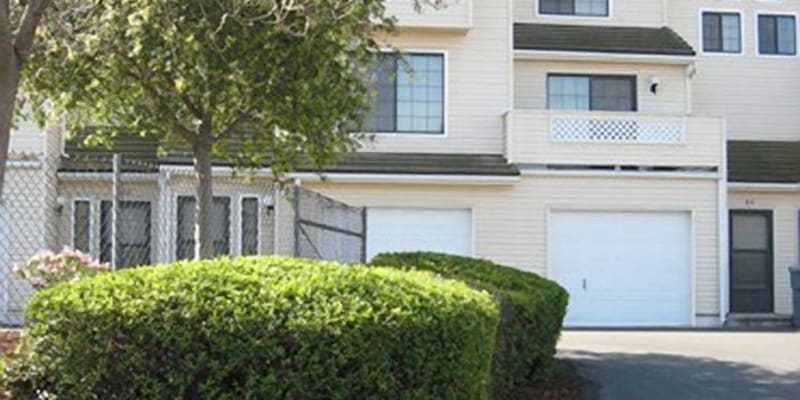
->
{"left": 367, "top": 54, "right": 444, "bottom": 134}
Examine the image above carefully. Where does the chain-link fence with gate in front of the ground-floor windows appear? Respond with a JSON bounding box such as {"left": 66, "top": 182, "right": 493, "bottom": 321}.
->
{"left": 0, "top": 154, "right": 366, "bottom": 326}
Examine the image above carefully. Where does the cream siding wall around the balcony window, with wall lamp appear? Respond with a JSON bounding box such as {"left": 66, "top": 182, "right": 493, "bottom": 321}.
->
{"left": 514, "top": 60, "right": 687, "bottom": 115}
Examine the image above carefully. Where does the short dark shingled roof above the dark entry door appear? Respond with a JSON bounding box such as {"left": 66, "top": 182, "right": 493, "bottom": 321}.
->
{"left": 728, "top": 141, "right": 800, "bottom": 183}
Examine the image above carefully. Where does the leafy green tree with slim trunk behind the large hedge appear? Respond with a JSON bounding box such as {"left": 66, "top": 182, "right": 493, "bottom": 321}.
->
{"left": 24, "top": 0, "right": 440, "bottom": 258}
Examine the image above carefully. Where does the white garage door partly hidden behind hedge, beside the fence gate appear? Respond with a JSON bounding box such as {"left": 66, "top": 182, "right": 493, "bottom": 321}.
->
{"left": 367, "top": 208, "right": 472, "bottom": 259}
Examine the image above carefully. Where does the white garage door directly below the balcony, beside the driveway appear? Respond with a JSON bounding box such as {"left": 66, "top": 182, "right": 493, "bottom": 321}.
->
{"left": 549, "top": 212, "right": 692, "bottom": 326}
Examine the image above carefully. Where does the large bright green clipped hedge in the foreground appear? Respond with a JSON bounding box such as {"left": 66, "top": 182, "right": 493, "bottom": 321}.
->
{"left": 1, "top": 258, "right": 499, "bottom": 399}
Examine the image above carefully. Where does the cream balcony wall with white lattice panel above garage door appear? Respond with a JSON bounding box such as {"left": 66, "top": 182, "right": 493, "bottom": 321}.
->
{"left": 505, "top": 110, "right": 725, "bottom": 168}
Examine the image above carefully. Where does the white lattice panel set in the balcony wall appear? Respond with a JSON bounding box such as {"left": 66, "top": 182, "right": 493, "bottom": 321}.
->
{"left": 550, "top": 113, "right": 686, "bottom": 144}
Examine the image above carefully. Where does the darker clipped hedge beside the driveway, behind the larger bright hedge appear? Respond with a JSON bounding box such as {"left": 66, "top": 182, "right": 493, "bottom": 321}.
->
{"left": 372, "top": 253, "right": 569, "bottom": 399}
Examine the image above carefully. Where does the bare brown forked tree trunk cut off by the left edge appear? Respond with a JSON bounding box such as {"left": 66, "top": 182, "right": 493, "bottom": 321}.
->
{"left": 0, "top": 0, "right": 50, "bottom": 196}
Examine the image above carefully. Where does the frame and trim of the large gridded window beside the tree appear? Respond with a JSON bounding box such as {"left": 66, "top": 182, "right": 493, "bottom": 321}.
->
{"left": 366, "top": 51, "right": 447, "bottom": 136}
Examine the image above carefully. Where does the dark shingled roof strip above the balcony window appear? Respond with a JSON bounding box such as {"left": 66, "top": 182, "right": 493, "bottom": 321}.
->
{"left": 514, "top": 23, "right": 695, "bottom": 56}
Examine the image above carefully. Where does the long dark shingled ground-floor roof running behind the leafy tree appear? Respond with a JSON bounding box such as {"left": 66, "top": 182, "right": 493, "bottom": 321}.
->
{"left": 59, "top": 135, "right": 520, "bottom": 176}
